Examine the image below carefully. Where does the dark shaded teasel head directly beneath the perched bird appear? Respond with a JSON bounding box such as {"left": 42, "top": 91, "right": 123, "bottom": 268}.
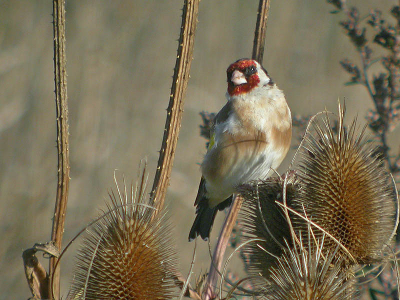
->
{"left": 238, "top": 176, "right": 298, "bottom": 282}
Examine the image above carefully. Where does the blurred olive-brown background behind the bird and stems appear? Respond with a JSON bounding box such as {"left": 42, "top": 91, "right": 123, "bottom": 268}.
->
{"left": 0, "top": 0, "right": 400, "bottom": 299}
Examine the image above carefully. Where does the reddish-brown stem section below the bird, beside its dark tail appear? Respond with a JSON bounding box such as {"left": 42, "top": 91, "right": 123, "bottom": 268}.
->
{"left": 203, "top": 195, "right": 243, "bottom": 300}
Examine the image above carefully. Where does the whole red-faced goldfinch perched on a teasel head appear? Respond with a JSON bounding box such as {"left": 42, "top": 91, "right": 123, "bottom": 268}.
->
{"left": 189, "top": 58, "right": 292, "bottom": 241}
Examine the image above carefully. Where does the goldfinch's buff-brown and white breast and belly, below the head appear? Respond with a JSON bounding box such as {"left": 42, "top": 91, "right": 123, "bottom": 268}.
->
{"left": 202, "top": 91, "right": 292, "bottom": 185}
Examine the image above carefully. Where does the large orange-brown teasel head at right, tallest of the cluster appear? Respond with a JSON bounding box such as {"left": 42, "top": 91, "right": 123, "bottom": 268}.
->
{"left": 291, "top": 105, "right": 397, "bottom": 264}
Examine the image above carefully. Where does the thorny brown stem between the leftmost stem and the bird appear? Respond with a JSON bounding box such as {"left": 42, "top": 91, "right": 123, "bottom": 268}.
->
{"left": 150, "top": 0, "right": 200, "bottom": 211}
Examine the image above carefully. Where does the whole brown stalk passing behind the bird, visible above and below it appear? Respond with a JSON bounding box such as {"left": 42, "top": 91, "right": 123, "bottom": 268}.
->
{"left": 203, "top": 0, "right": 270, "bottom": 300}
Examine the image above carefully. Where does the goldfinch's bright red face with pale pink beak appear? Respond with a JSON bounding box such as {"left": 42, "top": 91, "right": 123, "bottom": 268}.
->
{"left": 226, "top": 59, "right": 260, "bottom": 96}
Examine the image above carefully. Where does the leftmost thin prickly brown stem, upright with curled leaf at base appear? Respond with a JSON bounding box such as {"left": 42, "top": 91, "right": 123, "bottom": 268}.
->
{"left": 49, "top": 0, "right": 69, "bottom": 299}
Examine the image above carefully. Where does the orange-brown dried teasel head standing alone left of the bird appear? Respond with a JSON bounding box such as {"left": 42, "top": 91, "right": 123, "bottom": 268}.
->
{"left": 69, "top": 171, "right": 176, "bottom": 300}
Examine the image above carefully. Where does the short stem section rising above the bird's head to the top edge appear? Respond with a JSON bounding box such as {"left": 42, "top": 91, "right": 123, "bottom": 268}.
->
{"left": 252, "top": 0, "right": 270, "bottom": 64}
